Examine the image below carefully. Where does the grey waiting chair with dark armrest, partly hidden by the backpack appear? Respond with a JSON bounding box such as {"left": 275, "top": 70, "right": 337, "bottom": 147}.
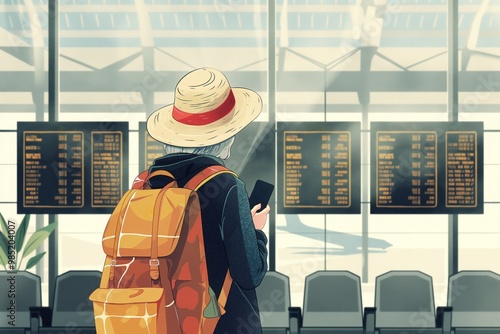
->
{"left": 30, "top": 270, "right": 101, "bottom": 334}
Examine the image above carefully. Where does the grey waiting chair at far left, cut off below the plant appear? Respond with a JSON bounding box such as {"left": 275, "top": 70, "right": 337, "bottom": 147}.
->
{"left": 0, "top": 271, "right": 42, "bottom": 334}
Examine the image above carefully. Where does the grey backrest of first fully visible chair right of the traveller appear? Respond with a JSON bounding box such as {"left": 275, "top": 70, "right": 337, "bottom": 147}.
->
{"left": 302, "top": 271, "right": 363, "bottom": 327}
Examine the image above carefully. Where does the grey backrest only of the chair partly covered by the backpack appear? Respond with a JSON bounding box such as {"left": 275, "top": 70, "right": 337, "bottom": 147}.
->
{"left": 52, "top": 270, "right": 101, "bottom": 327}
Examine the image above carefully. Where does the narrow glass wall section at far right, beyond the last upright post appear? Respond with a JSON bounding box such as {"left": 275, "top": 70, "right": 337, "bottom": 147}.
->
{"left": 458, "top": 0, "right": 500, "bottom": 272}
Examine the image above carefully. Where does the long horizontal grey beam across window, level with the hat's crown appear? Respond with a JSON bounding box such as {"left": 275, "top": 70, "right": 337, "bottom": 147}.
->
{"left": 0, "top": 71, "right": 500, "bottom": 93}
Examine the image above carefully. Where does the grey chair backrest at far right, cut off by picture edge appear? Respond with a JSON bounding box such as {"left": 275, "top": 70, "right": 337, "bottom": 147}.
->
{"left": 448, "top": 271, "right": 500, "bottom": 327}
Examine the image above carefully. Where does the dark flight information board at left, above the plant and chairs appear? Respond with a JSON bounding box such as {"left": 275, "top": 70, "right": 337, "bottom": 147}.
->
{"left": 17, "top": 122, "right": 128, "bottom": 214}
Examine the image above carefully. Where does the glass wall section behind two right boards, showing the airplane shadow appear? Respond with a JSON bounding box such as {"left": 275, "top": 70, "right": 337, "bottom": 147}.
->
{"left": 276, "top": 0, "right": 448, "bottom": 306}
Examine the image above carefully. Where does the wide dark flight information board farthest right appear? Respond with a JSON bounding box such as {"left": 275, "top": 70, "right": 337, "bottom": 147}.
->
{"left": 370, "top": 122, "right": 484, "bottom": 214}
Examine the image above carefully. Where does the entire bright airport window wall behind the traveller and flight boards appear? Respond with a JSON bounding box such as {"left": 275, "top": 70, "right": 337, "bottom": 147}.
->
{"left": 0, "top": 0, "right": 500, "bottom": 314}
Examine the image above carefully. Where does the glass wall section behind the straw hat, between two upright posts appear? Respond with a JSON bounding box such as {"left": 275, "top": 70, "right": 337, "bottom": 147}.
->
{"left": 54, "top": 0, "right": 268, "bottom": 290}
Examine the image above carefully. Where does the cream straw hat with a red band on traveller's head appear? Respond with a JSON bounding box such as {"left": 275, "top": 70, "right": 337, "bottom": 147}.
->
{"left": 147, "top": 68, "right": 262, "bottom": 147}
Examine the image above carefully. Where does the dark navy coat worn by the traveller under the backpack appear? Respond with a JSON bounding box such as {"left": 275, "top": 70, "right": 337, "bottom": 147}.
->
{"left": 149, "top": 153, "right": 267, "bottom": 334}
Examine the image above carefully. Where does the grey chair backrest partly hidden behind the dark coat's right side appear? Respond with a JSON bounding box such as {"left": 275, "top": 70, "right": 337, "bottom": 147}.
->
{"left": 256, "top": 271, "right": 290, "bottom": 328}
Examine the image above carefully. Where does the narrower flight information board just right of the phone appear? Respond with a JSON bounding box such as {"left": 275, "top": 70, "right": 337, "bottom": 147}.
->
{"left": 278, "top": 122, "right": 361, "bottom": 214}
